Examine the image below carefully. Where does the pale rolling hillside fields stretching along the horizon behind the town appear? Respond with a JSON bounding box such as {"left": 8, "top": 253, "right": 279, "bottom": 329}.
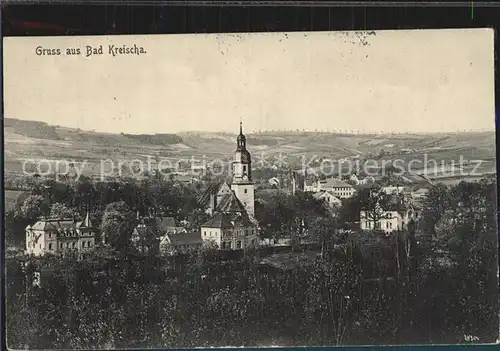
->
{"left": 4, "top": 118, "right": 496, "bottom": 184}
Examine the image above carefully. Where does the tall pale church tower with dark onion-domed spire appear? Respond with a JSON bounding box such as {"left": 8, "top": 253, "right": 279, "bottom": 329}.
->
{"left": 231, "top": 122, "right": 255, "bottom": 217}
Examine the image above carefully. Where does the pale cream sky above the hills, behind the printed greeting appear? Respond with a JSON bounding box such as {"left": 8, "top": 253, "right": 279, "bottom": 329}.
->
{"left": 4, "top": 29, "right": 495, "bottom": 134}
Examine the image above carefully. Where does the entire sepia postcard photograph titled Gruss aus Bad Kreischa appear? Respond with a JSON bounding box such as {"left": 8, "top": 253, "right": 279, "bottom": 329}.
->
{"left": 3, "top": 28, "right": 500, "bottom": 350}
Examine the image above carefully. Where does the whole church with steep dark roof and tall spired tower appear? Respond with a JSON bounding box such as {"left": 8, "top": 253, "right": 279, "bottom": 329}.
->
{"left": 199, "top": 122, "right": 259, "bottom": 250}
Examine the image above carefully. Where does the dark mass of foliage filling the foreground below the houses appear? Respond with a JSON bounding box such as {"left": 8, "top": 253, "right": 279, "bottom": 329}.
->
{"left": 6, "top": 234, "right": 498, "bottom": 349}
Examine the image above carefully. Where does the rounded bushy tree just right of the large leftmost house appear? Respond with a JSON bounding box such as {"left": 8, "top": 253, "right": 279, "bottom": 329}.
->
{"left": 101, "top": 201, "right": 136, "bottom": 251}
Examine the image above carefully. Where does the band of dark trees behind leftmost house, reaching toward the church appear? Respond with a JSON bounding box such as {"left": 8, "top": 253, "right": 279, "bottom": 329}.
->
{"left": 5, "top": 177, "right": 200, "bottom": 247}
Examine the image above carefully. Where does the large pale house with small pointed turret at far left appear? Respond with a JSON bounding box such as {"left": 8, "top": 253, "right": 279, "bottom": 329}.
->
{"left": 26, "top": 213, "right": 97, "bottom": 256}
